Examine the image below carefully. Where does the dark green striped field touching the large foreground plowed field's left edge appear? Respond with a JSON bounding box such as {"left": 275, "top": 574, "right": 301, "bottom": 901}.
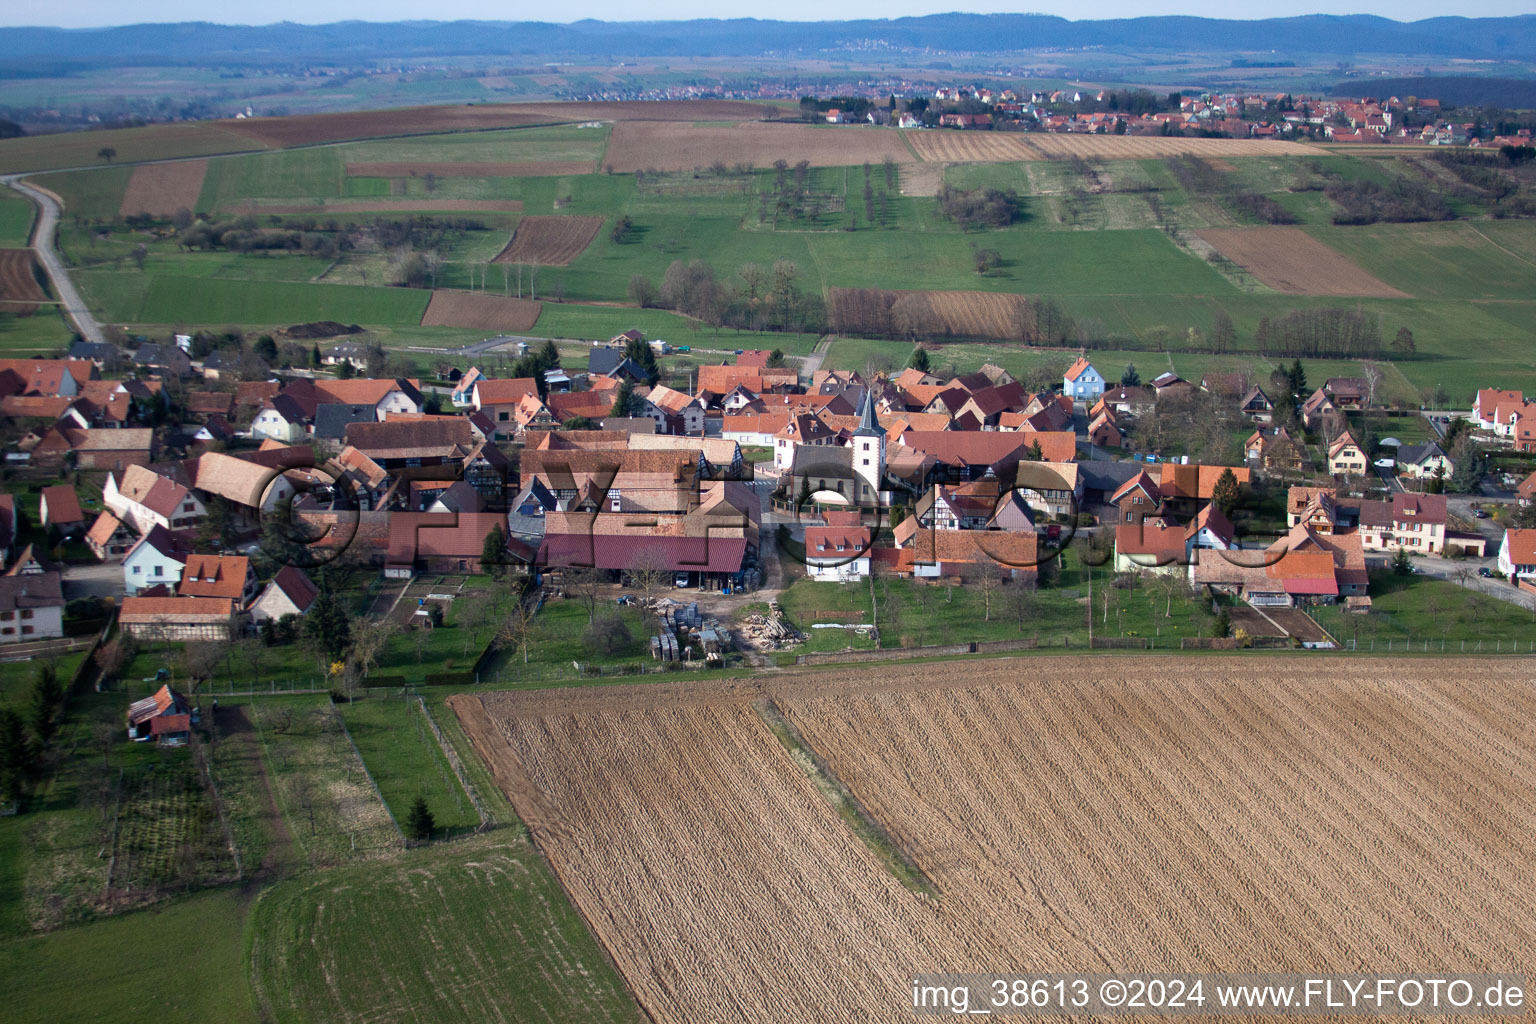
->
{"left": 250, "top": 832, "right": 639, "bottom": 1024}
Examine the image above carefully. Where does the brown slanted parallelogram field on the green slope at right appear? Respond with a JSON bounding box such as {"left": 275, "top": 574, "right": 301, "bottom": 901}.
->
{"left": 1195, "top": 227, "right": 1412, "bottom": 299}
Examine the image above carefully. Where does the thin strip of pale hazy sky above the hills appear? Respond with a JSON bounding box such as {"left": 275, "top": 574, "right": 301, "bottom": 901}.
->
{"left": 12, "top": 0, "right": 1531, "bottom": 28}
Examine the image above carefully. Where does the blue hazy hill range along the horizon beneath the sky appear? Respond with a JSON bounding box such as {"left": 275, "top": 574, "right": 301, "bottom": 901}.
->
{"left": 9, "top": 14, "right": 1536, "bottom": 65}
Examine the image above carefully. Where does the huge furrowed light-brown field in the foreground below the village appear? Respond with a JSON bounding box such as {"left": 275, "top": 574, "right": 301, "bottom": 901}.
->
{"left": 450, "top": 657, "right": 1536, "bottom": 1024}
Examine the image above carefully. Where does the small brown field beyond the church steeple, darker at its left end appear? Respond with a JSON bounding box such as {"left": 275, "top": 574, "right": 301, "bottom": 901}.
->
{"left": 829, "top": 289, "right": 1025, "bottom": 339}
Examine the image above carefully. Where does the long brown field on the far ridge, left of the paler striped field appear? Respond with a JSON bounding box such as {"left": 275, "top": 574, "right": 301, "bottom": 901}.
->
{"left": 604, "top": 121, "right": 912, "bottom": 172}
